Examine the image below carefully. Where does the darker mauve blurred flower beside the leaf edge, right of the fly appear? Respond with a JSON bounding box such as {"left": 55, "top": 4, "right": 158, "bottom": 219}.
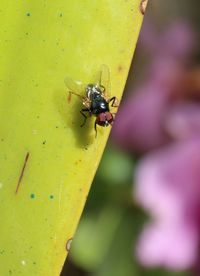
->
{"left": 112, "top": 20, "right": 197, "bottom": 153}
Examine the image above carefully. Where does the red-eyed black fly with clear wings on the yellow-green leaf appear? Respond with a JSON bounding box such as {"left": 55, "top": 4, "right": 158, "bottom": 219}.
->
{"left": 65, "top": 65, "right": 119, "bottom": 136}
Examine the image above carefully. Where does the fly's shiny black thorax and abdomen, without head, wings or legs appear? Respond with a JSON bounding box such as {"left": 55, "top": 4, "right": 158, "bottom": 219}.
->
{"left": 86, "top": 84, "right": 110, "bottom": 115}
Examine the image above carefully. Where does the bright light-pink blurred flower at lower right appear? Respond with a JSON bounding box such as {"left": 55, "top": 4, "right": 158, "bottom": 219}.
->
{"left": 134, "top": 140, "right": 200, "bottom": 269}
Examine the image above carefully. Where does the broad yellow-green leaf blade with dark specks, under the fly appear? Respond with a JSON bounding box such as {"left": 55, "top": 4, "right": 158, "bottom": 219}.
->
{"left": 0, "top": 0, "right": 145, "bottom": 275}
